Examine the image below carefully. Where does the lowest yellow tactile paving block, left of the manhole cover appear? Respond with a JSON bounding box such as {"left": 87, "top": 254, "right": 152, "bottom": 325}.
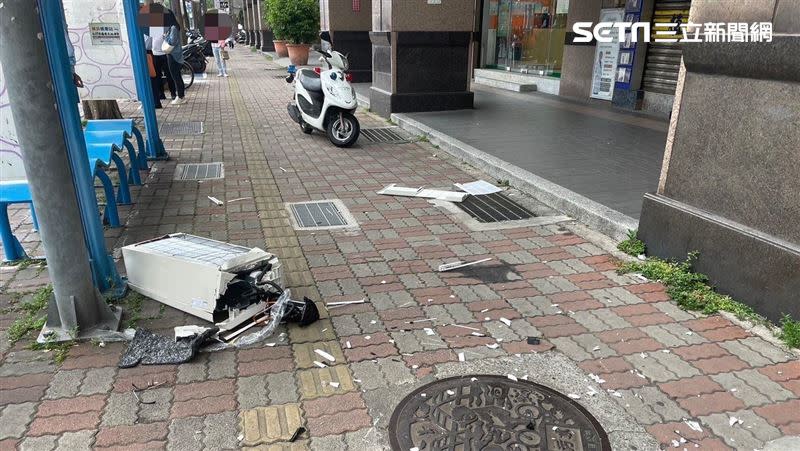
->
{"left": 239, "top": 404, "right": 304, "bottom": 446}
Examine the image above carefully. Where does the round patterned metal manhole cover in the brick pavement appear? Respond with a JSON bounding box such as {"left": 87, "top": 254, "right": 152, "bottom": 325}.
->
{"left": 389, "top": 375, "right": 611, "bottom": 451}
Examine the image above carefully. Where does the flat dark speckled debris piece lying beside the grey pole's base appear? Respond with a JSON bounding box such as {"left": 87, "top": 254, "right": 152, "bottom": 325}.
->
{"left": 119, "top": 327, "right": 219, "bottom": 368}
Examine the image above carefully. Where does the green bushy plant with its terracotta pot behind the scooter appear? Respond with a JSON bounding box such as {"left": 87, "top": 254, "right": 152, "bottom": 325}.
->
{"left": 268, "top": 0, "right": 319, "bottom": 66}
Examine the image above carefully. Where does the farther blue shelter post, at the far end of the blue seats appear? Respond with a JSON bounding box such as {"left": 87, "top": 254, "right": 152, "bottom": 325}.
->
{"left": 122, "top": 0, "right": 169, "bottom": 160}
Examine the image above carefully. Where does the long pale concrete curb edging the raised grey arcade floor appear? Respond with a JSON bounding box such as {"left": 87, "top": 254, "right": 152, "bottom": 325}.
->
{"left": 391, "top": 113, "right": 639, "bottom": 241}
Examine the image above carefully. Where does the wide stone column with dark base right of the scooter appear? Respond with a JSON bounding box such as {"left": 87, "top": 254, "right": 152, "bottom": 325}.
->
{"left": 370, "top": 0, "right": 479, "bottom": 117}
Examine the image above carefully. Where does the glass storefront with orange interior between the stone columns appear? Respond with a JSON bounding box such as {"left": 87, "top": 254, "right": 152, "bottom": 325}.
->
{"left": 484, "top": 0, "right": 569, "bottom": 76}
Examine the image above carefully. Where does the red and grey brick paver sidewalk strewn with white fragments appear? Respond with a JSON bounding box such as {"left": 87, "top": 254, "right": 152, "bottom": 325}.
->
{"left": 0, "top": 48, "right": 800, "bottom": 450}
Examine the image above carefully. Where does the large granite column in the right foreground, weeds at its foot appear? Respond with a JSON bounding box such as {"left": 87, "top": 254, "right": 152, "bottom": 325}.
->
{"left": 639, "top": 0, "right": 800, "bottom": 320}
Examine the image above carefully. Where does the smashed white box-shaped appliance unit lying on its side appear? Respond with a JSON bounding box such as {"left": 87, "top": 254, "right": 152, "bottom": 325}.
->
{"left": 122, "top": 233, "right": 283, "bottom": 331}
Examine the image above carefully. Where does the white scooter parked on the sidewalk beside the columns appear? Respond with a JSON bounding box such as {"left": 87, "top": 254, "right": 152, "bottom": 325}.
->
{"left": 286, "top": 31, "right": 361, "bottom": 147}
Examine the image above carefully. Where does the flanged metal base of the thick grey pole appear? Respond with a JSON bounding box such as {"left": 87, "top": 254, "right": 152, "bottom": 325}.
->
{"left": 36, "top": 292, "right": 122, "bottom": 343}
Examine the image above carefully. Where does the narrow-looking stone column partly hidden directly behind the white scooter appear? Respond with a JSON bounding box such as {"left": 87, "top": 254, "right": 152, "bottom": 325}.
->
{"left": 319, "top": 0, "right": 372, "bottom": 83}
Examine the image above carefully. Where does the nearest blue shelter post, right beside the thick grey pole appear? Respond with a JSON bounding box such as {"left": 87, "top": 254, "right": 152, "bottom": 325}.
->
{"left": 37, "top": 0, "right": 125, "bottom": 294}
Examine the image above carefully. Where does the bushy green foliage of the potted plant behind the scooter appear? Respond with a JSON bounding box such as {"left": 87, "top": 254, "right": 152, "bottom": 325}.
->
{"left": 266, "top": 0, "right": 319, "bottom": 44}
